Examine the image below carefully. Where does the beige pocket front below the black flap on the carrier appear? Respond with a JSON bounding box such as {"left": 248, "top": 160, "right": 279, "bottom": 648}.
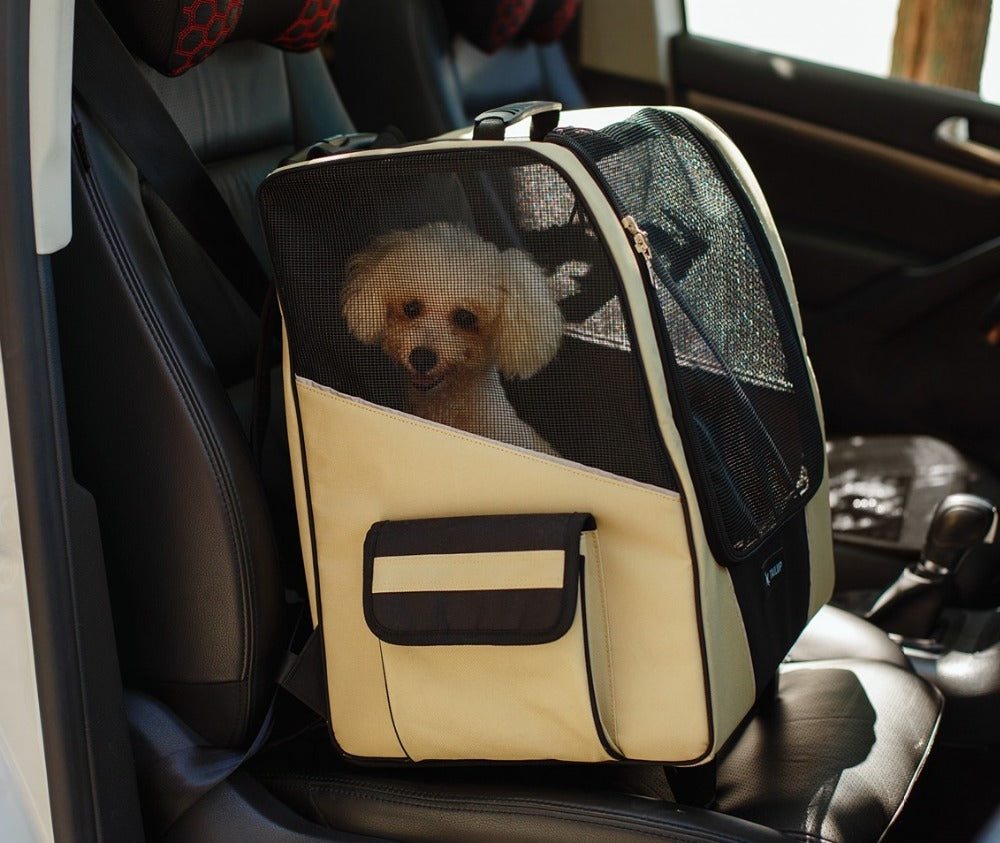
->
{"left": 381, "top": 606, "right": 610, "bottom": 761}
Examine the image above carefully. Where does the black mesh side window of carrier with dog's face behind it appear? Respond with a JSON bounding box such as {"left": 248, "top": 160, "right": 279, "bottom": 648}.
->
{"left": 259, "top": 148, "right": 677, "bottom": 489}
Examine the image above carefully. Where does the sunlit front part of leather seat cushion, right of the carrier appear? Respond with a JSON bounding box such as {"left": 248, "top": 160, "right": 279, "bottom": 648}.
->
{"left": 718, "top": 659, "right": 943, "bottom": 841}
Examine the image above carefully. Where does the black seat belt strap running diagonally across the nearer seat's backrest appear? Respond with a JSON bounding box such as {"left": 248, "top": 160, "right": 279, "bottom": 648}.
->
{"left": 73, "top": 0, "right": 269, "bottom": 313}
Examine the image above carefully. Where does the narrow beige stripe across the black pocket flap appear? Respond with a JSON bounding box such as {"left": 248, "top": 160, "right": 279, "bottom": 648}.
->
{"left": 372, "top": 550, "right": 566, "bottom": 594}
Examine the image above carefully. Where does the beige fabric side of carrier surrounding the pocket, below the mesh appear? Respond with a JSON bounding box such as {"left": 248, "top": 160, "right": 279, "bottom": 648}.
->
{"left": 297, "top": 379, "right": 716, "bottom": 761}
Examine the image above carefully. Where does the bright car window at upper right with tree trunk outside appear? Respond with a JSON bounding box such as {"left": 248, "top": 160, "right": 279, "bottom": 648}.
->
{"left": 685, "top": 0, "right": 1000, "bottom": 102}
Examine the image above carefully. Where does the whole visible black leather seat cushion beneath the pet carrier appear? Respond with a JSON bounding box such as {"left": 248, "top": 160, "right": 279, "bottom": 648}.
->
{"left": 255, "top": 659, "right": 941, "bottom": 843}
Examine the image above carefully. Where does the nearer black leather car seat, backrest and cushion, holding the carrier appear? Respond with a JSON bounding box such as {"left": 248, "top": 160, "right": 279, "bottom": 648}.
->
{"left": 54, "top": 0, "right": 940, "bottom": 841}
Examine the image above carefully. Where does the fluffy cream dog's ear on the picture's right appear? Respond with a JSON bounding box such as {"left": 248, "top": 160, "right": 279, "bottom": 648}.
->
{"left": 494, "top": 249, "right": 565, "bottom": 378}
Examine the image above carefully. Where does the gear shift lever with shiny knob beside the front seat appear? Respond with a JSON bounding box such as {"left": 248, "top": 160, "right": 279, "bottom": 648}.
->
{"left": 867, "top": 494, "right": 997, "bottom": 638}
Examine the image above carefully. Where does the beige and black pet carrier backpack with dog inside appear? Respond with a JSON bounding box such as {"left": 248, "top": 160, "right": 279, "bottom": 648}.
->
{"left": 258, "top": 103, "right": 833, "bottom": 765}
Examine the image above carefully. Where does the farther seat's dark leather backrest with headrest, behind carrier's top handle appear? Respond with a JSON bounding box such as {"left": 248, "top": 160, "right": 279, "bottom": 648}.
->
{"left": 331, "top": 0, "right": 586, "bottom": 140}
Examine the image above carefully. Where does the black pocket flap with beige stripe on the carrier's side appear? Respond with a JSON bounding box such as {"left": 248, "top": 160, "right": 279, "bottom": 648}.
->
{"left": 364, "top": 513, "right": 596, "bottom": 645}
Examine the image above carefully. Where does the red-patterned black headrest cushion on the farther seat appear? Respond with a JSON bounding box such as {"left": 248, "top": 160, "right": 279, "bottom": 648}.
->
{"left": 442, "top": 0, "right": 580, "bottom": 53}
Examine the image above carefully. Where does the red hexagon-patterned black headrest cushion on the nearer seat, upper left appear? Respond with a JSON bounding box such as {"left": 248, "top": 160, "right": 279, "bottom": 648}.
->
{"left": 101, "top": 0, "right": 340, "bottom": 76}
